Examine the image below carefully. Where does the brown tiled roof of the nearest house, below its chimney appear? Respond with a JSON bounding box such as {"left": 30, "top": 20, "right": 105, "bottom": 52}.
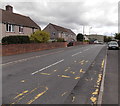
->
{"left": 1, "top": 9, "right": 40, "bottom": 29}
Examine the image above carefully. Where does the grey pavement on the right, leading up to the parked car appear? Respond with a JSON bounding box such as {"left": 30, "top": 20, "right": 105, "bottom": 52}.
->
{"left": 102, "top": 50, "right": 120, "bottom": 106}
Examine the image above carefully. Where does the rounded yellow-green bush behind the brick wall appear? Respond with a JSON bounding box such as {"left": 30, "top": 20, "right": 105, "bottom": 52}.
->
{"left": 30, "top": 30, "right": 50, "bottom": 43}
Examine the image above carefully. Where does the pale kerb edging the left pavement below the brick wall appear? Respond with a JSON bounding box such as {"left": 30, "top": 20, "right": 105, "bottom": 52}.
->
{"left": 1, "top": 50, "right": 64, "bottom": 66}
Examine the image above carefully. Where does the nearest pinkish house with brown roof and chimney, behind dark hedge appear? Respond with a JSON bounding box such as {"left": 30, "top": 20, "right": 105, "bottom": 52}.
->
{"left": 0, "top": 5, "right": 41, "bottom": 40}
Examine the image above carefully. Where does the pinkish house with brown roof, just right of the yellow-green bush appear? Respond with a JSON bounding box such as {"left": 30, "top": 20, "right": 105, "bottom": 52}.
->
{"left": 43, "top": 23, "right": 76, "bottom": 42}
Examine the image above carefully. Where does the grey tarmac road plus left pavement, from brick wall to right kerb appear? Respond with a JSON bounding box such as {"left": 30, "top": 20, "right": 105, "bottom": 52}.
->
{"left": 2, "top": 45, "right": 106, "bottom": 104}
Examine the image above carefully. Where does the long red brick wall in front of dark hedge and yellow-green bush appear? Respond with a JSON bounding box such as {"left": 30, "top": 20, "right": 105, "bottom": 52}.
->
{"left": 2, "top": 42, "right": 67, "bottom": 56}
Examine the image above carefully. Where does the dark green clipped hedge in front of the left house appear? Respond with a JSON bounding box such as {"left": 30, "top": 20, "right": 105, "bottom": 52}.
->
{"left": 2, "top": 35, "right": 30, "bottom": 44}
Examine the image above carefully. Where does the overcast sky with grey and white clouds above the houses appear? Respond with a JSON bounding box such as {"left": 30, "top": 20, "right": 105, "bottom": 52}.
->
{"left": 0, "top": 0, "right": 119, "bottom": 36}
